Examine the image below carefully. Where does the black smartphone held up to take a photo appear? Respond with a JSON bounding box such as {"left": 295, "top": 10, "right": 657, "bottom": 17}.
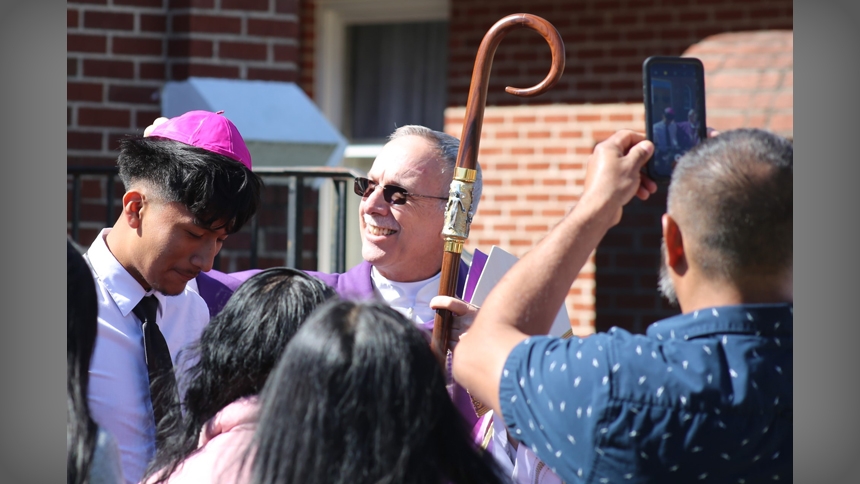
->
{"left": 642, "top": 56, "right": 708, "bottom": 180}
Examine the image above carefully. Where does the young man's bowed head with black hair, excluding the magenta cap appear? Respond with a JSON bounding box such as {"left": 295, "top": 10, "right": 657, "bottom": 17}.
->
{"left": 105, "top": 137, "right": 262, "bottom": 296}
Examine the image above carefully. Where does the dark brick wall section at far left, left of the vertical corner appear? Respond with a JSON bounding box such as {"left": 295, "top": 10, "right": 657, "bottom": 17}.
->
{"left": 67, "top": 0, "right": 167, "bottom": 165}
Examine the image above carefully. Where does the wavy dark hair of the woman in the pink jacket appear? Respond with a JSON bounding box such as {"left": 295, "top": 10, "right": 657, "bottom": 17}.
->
{"left": 148, "top": 267, "right": 335, "bottom": 479}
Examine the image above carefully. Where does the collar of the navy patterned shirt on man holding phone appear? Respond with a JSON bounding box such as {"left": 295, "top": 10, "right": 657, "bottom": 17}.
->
{"left": 646, "top": 303, "right": 794, "bottom": 341}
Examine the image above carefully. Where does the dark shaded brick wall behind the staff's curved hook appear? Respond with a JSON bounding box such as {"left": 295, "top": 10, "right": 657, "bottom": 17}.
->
{"left": 448, "top": 0, "right": 793, "bottom": 106}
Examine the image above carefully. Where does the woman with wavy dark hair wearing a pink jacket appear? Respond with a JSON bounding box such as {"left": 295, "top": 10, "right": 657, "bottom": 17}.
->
{"left": 144, "top": 267, "right": 335, "bottom": 484}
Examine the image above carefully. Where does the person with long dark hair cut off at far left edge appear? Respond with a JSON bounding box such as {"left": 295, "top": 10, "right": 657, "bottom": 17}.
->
{"left": 66, "top": 240, "right": 122, "bottom": 484}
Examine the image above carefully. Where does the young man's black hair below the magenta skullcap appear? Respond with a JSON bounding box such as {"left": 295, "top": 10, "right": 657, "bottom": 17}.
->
{"left": 117, "top": 138, "right": 263, "bottom": 234}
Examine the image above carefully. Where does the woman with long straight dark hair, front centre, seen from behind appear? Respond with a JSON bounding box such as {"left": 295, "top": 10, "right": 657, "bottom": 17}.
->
{"left": 252, "top": 301, "right": 503, "bottom": 484}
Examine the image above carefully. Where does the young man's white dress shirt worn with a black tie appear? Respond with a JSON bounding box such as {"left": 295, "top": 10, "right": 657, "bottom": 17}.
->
{"left": 86, "top": 229, "right": 209, "bottom": 484}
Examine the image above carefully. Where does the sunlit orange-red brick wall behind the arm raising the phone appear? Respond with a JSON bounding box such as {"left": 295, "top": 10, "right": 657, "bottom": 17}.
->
{"left": 445, "top": 104, "right": 665, "bottom": 334}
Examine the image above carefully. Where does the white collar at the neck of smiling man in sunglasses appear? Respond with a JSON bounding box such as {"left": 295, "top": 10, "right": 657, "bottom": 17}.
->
{"left": 370, "top": 267, "right": 442, "bottom": 330}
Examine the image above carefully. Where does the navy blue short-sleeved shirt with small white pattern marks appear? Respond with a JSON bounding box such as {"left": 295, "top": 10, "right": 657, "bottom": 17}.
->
{"left": 499, "top": 304, "right": 793, "bottom": 484}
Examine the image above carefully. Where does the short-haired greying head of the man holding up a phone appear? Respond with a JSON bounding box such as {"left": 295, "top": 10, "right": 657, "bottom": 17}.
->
{"left": 668, "top": 129, "right": 794, "bottom": 280}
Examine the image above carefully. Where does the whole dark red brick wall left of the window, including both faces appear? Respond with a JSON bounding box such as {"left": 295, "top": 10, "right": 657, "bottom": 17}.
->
{"left": 67, "top": 0, "right": 306, "bottom": 250}
